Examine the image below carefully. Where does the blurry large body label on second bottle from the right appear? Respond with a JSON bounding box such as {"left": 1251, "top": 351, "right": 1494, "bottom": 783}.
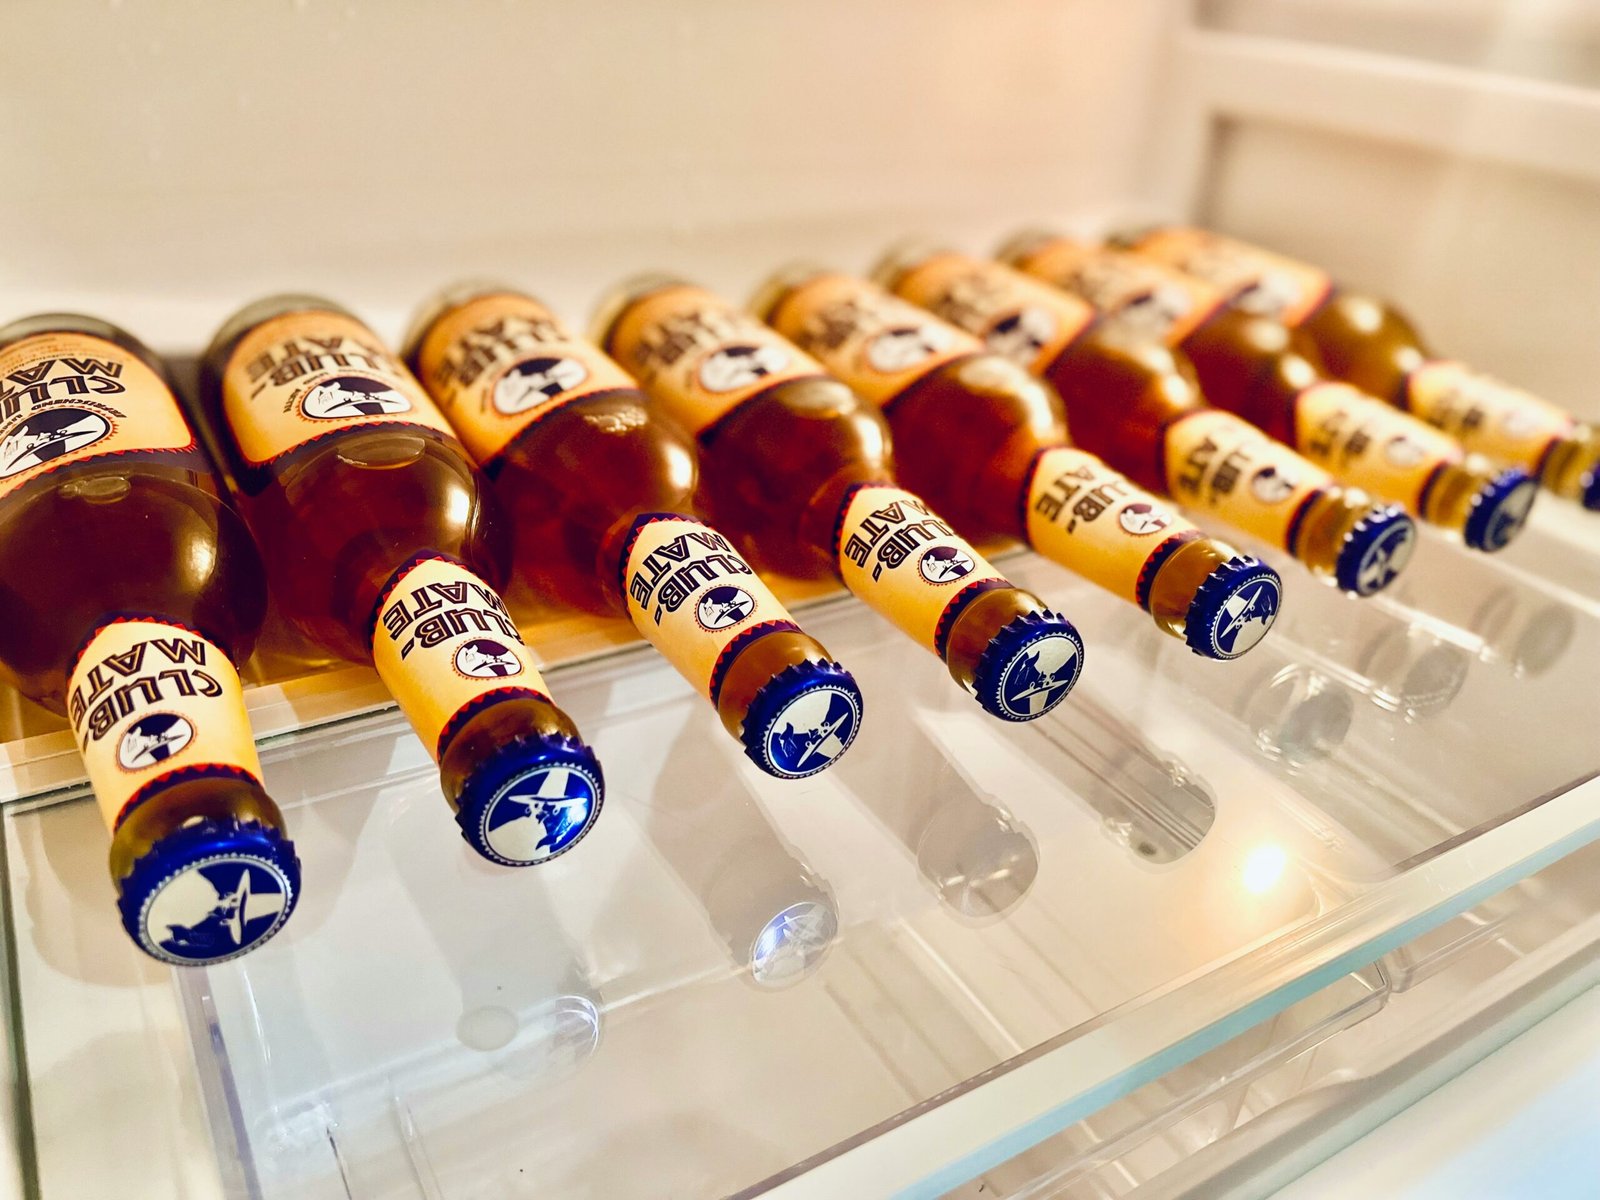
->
{"left": 1018, "top": 237, "right": 1226, "bottom": 346}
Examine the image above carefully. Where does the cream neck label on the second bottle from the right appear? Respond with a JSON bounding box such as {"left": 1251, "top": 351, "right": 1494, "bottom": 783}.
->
{"left": 1294, "top": 382, "right": 1461, "bottom": 512}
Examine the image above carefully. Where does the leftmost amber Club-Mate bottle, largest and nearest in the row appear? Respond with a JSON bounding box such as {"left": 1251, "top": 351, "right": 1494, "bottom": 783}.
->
{"left": 0, "top": 314, "right": 299, "bottom": 965}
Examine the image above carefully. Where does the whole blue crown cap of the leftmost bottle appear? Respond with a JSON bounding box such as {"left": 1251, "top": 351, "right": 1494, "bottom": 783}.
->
{"left": 117, "top": 818, "right": 299, "bottom": 966}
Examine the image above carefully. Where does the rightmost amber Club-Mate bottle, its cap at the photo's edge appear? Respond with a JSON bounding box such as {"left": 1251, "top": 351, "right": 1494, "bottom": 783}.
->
{"left": 1118, "top": 226, "right": 1600, "bottom": 510}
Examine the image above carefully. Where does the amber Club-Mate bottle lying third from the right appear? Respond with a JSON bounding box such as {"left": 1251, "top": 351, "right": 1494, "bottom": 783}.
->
{"left": 875, "top": 245, "right": 1416, "bottom": 595}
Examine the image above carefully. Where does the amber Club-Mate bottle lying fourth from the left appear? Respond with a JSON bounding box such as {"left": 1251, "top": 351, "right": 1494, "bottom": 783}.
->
{"left": 597, "top": 275, "right": 1083, "bottom": 720}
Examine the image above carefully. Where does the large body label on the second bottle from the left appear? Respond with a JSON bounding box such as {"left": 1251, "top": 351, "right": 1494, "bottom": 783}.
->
{"left": 222, "top": 310, "right": 451, "bottom": 467}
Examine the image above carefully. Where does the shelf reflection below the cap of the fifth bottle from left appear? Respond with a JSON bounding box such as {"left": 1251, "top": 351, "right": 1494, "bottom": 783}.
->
{"left": 1038, "top": 704, "right": 1216, "bottom": 862}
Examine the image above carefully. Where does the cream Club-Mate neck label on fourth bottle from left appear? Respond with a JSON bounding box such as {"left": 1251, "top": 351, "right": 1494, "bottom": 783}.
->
{"left": 834, "top": 483, "right": 1010, "bottom": 658}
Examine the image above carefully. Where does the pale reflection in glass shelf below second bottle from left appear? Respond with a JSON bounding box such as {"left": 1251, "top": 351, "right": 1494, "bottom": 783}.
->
{"left": 387, "top": 787, "right": 603, "bottom": 1078}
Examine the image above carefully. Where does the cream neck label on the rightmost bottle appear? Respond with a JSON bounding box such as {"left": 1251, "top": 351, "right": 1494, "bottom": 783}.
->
{"left": 1406, "top": 362, "right": 1576, "bottom": 472}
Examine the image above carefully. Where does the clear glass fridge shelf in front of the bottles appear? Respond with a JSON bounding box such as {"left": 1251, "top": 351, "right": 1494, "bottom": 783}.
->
{"left": 3, "top": 504, "right": 1600, "bottom": 1200}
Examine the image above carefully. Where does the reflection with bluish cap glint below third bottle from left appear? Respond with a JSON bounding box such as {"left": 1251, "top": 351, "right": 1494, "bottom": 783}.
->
{"left": 645, "top": 742, "right": 838, "bottom": 987}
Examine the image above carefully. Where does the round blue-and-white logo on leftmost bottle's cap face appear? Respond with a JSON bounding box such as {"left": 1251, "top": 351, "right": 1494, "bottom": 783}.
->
{"left": 144, "top": 858, "right": 293, "bottom": 963}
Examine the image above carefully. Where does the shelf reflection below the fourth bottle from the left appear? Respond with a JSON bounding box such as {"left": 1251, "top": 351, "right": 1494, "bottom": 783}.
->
{"left": 840, "top": 709, "right": 1046, "bottom": 920}
